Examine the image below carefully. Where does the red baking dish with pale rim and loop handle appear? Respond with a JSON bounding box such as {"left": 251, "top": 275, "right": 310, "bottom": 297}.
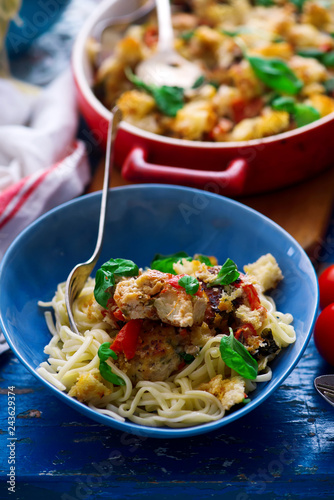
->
{"left": 72, "top": 0, "right": 334, "bottom": 196}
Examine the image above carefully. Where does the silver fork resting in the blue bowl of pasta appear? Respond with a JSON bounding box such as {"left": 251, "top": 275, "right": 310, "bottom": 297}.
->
{"left": 65, "top": 106, "right": 122, "bottom": 335}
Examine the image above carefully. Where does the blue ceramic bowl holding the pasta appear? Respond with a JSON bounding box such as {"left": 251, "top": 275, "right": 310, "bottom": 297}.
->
{"left": 0, "top": 184, "right": 318, "bottom": 438}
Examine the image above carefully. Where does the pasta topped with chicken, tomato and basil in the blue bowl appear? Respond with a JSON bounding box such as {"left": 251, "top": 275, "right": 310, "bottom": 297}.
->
{"left": 38, "top": 252, "right": 296, "bottom": 427}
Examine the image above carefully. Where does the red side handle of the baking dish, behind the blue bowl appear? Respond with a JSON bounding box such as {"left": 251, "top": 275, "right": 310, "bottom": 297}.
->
{"left": 122, "top": 147, "right": 248, "bottom": 196}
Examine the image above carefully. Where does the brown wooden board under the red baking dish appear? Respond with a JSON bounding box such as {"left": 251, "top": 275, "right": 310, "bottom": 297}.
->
{"left": 88, "top": 161, "right": 334, "bottom": 257}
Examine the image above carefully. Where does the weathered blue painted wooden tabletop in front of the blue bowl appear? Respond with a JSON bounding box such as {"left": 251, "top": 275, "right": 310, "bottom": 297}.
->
{"left": 0, "top": 324, "right": 334, "bottom": 500}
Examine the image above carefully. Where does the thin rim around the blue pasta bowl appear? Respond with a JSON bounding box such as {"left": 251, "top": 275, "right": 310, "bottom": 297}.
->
{"left": 0, "top": 184, "right": 319, "bottom": 438}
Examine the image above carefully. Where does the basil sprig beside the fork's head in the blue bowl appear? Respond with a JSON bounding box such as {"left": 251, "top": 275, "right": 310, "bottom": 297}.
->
{"left": 94, "top": 259, "right": 139, "bottom": 309}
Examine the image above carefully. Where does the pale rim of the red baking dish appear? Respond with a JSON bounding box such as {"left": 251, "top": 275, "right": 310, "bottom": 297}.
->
{"left": 72, "top": 0, "right": 334, "bottom": 150}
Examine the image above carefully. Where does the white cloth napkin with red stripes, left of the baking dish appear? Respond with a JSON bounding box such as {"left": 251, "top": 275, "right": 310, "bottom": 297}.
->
{"left": 0, "top": 71, "right": 90, "bottom": 259}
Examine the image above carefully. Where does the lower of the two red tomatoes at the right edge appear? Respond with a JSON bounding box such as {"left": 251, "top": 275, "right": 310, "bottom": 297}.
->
{"left": 314, "top": 304, "right": 334, "bottom": 366}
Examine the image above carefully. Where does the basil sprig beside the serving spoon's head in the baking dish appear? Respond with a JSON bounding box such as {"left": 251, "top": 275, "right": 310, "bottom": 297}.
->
{"left": 126, "top": 70, "right": 184, "bottom": 117}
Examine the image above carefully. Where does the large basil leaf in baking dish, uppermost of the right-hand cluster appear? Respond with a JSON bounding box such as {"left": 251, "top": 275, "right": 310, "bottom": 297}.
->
{"left": 247, "top": 56, "right": 303, "bottom": 95}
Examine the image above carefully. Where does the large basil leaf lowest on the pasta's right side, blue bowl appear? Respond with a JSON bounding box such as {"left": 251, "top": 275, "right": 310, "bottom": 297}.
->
{"left": 219, "top": 328, "right": 258, "bottom": 380}
